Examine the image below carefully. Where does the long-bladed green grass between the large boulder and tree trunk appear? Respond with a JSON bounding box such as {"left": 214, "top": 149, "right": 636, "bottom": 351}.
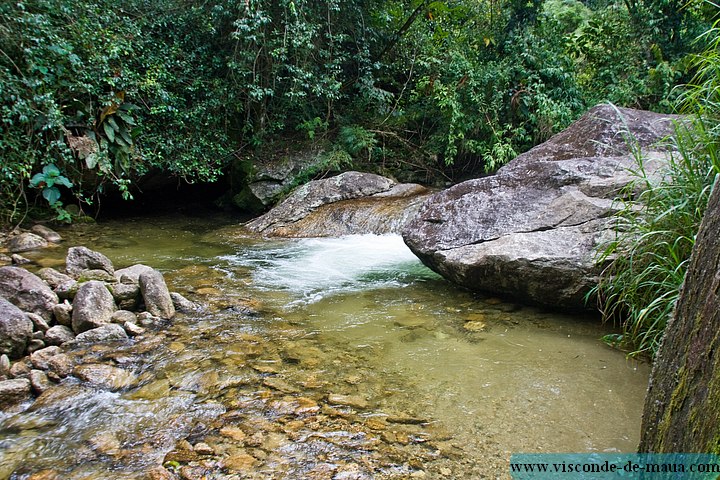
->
{"left": 598, "top": 9, "right": 720, "bottom": 356}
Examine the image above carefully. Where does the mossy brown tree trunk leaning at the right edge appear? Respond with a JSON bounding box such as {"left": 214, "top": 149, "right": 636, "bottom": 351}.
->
{"left": 639, "top": 179, "right": 720, "bottom": 454}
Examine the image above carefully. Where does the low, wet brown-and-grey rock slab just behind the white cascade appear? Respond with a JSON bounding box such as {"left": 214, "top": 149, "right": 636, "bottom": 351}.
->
{"left": 245, "top": 172, "right": 430, "bottom": 237}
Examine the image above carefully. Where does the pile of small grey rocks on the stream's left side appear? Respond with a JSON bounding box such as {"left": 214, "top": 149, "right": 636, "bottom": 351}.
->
{"left": 0, "top": 240, "right": 196, "bottom": 408}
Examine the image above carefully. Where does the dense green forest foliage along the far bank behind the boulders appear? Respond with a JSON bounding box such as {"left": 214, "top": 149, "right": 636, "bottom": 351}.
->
{"left": 0, "top": 0, "right": 710, "bottom": 222}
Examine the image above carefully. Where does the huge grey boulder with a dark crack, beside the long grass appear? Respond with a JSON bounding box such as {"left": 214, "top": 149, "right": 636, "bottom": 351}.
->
{"left": 403, "top": 106, "right": 678, "bottom": 310}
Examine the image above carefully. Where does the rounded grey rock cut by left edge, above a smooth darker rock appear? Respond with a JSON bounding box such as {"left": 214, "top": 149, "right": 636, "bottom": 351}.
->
{"left": 0, "top": 267, "right": 58, "bottom": 321}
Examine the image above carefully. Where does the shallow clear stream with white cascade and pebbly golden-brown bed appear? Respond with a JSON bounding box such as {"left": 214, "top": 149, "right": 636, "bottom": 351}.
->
{"left": 0, "top": 216, "right": 649, "bottom": 479}
